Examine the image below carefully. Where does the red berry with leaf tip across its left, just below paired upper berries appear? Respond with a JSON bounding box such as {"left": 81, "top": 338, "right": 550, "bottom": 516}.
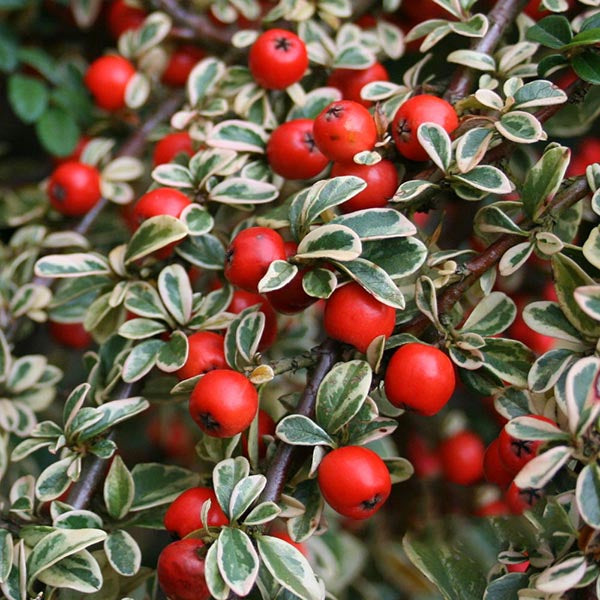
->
{"left": 331, "top": 160, "right": 398, "bottom": 213}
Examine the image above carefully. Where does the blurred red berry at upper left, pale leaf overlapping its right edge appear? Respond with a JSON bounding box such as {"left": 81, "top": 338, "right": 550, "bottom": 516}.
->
{"left": 84, "top": 54, "right": 135, "bottom": 111}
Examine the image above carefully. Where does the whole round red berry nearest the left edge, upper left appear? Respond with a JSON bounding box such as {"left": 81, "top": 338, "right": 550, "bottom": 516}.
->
{"left": 48, "top": 162, "right": 101, "bottom": 217}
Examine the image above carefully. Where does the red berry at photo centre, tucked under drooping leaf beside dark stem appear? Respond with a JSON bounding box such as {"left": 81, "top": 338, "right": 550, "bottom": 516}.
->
{"left": 323, "top": 282, "right": 396, "bottom": 352}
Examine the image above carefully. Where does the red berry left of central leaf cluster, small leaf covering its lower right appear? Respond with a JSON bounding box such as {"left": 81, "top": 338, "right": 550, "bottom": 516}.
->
{"left": 225, "top": 227, "right": 285, "bottom": 292}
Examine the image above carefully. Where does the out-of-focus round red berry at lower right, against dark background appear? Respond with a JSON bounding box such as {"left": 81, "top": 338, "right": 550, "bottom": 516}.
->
{"left": 439, "top": 431, "right": 485, "bottom": 485}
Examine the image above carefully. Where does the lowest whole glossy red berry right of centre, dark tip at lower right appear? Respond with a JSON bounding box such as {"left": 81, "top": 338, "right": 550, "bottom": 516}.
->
{"left": 318, "top": 446, "right": 392, "bottom": 519}
